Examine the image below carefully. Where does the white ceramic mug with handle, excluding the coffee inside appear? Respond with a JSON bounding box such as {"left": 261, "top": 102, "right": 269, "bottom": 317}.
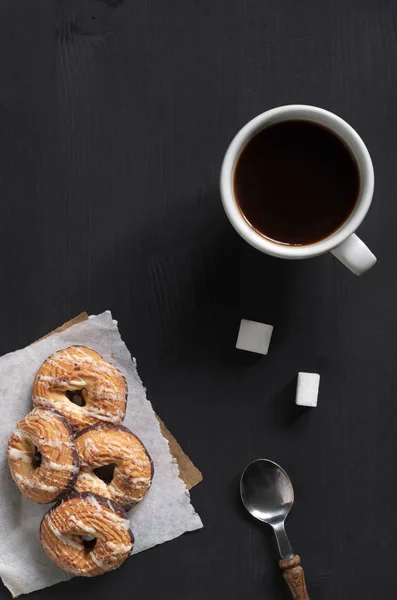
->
{"left": 220, "top": 104, "right": 376, "bottom": 275}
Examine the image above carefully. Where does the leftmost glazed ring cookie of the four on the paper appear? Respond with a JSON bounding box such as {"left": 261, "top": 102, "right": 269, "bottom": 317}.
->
{"left": 7, "top": 408, "right": 79, "bottom": 504}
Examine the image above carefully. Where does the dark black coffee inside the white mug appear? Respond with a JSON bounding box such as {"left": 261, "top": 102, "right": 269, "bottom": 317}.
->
{"left": 234, "top": 121, "right": 360, "bottom": 246}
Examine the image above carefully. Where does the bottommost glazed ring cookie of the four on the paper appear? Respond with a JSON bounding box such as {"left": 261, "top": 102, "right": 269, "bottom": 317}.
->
{"left": 40, "top": 493, "right": 134, "bottom": 577}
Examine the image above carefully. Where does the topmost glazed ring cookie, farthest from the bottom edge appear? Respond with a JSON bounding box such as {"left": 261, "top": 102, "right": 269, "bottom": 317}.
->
{"left": 33, "top": 346, "right": 127, "bottom": 431}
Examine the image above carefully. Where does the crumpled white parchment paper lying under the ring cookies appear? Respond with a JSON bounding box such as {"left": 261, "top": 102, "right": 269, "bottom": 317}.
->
{"left": 0, "top": 311, "right": 202, "bottom": 597}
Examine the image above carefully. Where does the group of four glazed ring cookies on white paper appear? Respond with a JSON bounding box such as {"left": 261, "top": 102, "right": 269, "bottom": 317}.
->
{"left": 7, "top": 346, "right": 153, "bottom": 576}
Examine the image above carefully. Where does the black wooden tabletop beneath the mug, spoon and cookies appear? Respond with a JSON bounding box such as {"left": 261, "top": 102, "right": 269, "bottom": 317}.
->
{"left": 0, "top": 0, "right": 397, "bottom": 600}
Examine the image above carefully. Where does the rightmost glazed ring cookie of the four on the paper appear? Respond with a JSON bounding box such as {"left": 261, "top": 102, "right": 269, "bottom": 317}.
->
{"left": 75, "top": 424, "right": 153, "bottom": 510}
